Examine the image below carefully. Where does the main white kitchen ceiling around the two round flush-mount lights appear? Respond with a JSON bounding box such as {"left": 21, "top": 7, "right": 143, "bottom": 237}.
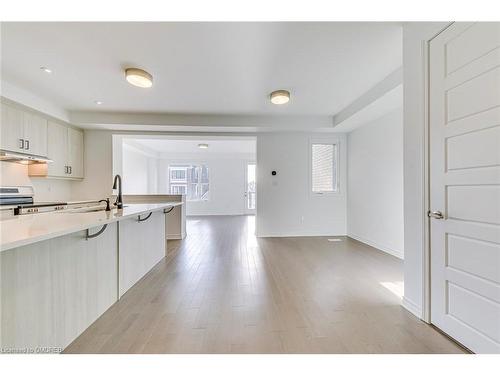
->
{"left": 1, "top": 22, "right": 402, "bottom": 116}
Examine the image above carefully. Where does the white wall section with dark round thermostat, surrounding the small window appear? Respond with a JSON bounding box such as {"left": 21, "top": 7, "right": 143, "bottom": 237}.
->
{"left": 256, "top": 133, "right": 346, "bottom": 236}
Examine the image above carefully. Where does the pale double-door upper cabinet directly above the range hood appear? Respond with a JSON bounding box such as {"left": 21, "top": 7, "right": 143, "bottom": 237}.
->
{"left": 0, "top": 103, "right": 47, "bottom": 156}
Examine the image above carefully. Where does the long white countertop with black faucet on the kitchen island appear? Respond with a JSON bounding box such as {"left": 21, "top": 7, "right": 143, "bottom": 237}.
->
{"left": 0, "top": 202, "right": 182, "bottom": 251}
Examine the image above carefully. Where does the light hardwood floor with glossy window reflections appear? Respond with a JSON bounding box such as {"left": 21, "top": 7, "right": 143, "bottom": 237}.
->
{"left": 65, "top": 216, "right": 463, "bottom": 353}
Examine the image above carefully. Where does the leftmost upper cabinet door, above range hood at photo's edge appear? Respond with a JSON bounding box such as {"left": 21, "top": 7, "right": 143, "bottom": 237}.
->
{"left": 0, "top": 103, "right": 25, "bottom": 152}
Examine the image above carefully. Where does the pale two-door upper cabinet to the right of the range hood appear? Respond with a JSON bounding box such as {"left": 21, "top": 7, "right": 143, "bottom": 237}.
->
{"left": 45, "top": 121, "right": 83, "bottom": 178}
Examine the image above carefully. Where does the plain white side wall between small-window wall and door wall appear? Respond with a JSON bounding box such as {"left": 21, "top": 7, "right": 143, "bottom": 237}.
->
{"left": 347, "top": 108, "right": 404, "bottom": 258}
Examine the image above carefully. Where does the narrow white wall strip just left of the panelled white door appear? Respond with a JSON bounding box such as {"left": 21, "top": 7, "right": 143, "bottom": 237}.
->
{"left": 403, "top": 22, "right": 448, "bottom": 317}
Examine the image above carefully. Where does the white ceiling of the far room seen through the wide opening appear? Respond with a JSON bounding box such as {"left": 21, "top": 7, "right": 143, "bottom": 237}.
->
{"left": 123, "top": 137, "right": 256, "bottom": 155}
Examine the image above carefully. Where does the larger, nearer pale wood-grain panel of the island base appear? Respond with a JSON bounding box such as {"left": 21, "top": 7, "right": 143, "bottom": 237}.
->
{"left": 0, "top": 223, "right": 118, "bottom": 353}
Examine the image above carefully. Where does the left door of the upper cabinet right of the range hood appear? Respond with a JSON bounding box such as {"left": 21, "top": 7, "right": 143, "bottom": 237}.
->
{"left": 47, "top": 121, "right": 69, "bottom": 177}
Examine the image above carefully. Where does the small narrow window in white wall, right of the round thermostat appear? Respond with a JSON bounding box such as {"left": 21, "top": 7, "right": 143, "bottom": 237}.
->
{"left": 311, "top": 143, "right": 338, "bottom": 194}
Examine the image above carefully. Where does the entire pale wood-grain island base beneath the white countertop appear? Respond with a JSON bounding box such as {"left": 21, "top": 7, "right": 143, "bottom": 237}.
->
{"left": 0, "top": 211, "right": 166, "bottom": 353}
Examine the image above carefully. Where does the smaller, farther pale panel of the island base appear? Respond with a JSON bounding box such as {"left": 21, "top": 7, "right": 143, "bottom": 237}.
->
{"left": 118, "top": 211, "right": 166, "bottom": 297}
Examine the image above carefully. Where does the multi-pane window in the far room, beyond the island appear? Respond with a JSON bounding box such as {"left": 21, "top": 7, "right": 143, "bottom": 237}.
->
{"left": 168, "top": 164, "right": 210, "bottom": 201}
